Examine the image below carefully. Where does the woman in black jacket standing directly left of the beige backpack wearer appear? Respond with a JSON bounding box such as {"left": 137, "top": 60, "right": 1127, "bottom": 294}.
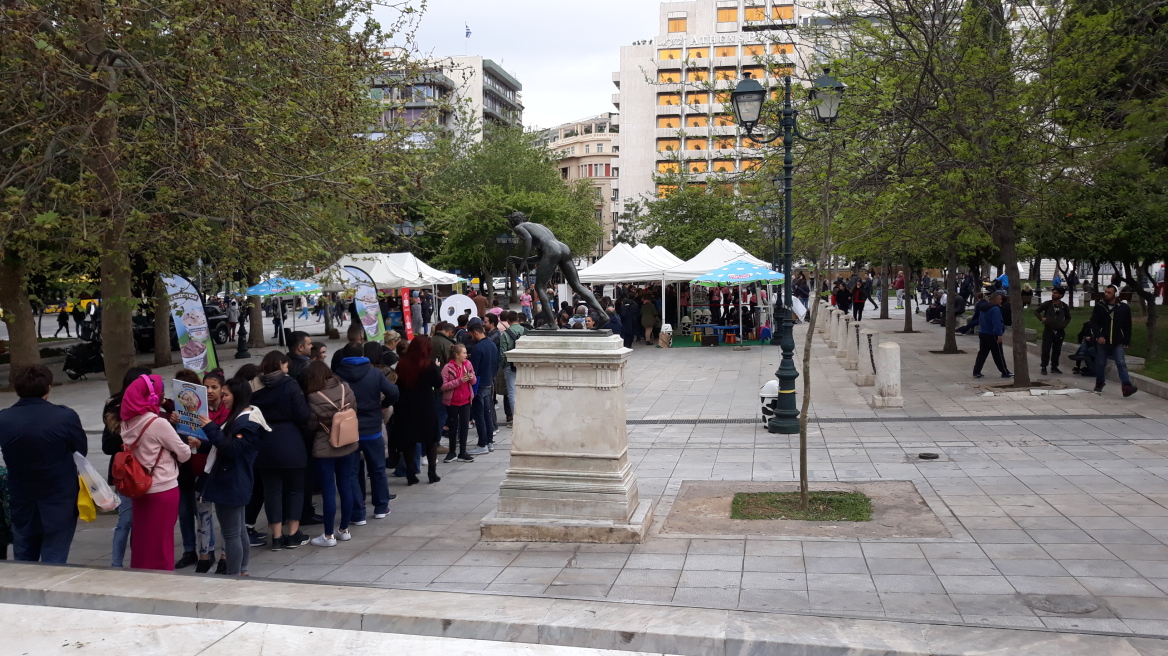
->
{"left": 251, "top": 351, "right": 308, "bottom": 551}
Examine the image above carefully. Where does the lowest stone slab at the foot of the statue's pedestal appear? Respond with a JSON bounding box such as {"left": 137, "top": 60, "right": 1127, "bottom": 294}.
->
{"left": 479, "top": 501, "right": 653, "bottom": 544}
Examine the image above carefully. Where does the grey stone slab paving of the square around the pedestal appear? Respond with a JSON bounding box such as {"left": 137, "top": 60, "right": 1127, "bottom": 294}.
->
{"left": 15, "top": 310, "right": 1168, "bottom": 635}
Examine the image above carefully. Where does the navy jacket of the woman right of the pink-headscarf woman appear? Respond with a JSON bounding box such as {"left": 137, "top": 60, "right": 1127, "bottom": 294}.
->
{"left": 202, "top": 417, "right": 265, "bottom": 508}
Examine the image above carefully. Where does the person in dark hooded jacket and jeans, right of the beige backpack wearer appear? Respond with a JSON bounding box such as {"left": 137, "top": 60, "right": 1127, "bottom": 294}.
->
{"left": 334, "top": 344, "right": 398, "bottom": 526}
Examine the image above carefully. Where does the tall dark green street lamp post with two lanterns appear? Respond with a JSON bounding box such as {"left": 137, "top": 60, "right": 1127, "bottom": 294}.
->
{"left": 730, "top": 69, "right": 844, "bottom": 435}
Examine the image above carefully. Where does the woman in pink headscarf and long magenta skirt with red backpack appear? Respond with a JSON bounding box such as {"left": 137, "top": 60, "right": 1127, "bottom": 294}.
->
{"left": 121, "top": 375, "right": 199, "bottom": 572}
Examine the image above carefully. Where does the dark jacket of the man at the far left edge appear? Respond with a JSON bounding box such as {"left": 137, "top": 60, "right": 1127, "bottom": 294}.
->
{"left": 0, "top": 398, "right": 89, "bottom": 532}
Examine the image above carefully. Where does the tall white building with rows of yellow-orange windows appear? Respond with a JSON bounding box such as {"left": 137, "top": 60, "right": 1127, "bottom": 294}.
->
{"left": 612, "top": 0, "right": 809, "bottom": 204}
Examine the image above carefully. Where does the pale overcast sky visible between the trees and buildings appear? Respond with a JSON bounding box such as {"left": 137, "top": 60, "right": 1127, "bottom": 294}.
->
{"left": 378, "top": 0, "right": 659, "bottom": 127}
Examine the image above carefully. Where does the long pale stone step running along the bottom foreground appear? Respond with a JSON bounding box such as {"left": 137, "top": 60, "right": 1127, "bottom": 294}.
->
{"left": 0, "top": 563, "right": 1168, "bottom": 656}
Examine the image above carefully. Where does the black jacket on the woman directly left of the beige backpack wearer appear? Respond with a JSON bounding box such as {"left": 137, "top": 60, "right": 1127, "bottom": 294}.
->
{"left": 251, "top": 372, "right": 310, "bottom": 469}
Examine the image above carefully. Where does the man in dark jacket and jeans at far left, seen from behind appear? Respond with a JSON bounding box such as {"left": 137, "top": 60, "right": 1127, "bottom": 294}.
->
{"left": 0, "top": 364, "right": 88, "bottom": 565}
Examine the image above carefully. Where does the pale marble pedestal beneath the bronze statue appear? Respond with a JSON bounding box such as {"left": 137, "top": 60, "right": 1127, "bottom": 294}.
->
{"left": 480, "top": 330, "right": 653, "bottom": 543}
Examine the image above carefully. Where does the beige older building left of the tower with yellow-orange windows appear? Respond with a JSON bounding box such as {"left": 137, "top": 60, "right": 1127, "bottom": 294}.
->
{"left": 541, "top": 112, "right": 620, "bottom": 261}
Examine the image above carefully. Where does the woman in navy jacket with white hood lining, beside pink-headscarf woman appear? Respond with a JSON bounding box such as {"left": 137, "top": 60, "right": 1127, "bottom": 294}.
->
{"left": 200, "top": 381, "right": 262, "bottom": 575}
